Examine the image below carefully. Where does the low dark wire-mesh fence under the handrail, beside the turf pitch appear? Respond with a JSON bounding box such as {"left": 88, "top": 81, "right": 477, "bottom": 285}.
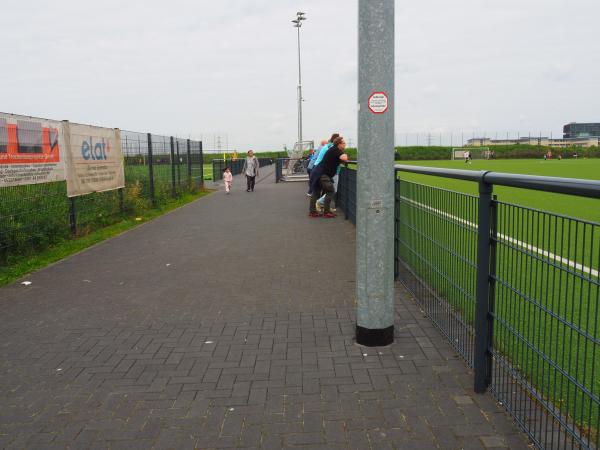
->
{"left": 338, "top": 165, "right": 600, "bottom": 449}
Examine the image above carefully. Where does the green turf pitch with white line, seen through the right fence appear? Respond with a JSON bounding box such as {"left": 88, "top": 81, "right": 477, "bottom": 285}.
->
{"left": 399, "top": 160, "right": 600, "bottom": 443}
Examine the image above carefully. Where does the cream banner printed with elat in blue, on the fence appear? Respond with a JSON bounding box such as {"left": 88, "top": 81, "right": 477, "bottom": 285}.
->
{"left": 63, "top": 123, "right": 125, "bottom": 197}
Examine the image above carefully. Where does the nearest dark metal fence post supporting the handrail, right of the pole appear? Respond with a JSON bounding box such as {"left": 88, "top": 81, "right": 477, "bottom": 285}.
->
{"left": 473, "top": 174, "right": 495, "bottom": 394}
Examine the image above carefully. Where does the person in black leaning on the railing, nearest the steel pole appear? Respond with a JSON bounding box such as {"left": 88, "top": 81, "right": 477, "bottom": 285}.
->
{"left": 309, "top": 136, "right": 348, "bottom": 219}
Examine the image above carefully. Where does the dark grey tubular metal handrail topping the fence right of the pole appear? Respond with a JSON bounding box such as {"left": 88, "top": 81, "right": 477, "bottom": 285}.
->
{"left": 394, "top": 164, "right": 600, "bottom": 198}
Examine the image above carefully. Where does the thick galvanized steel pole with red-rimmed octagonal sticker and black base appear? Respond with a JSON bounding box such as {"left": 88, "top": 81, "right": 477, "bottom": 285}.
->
{"left": 356, "top": 0, "right": 395, "bottom": 346}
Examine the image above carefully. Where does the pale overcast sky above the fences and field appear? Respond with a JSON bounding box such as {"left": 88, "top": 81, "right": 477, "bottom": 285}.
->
{"left": 0, "top": 0, "right": 600, "bottom": 150}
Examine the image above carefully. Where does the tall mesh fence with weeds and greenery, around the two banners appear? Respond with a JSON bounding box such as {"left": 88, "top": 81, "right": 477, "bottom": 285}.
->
{"left": 0, "top": 131, "right": 204, "bottom": 265}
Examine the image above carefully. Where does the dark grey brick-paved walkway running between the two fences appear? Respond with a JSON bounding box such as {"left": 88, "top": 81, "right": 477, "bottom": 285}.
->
{"left": 0, "top": 168, "right": 527, "bottom": 450}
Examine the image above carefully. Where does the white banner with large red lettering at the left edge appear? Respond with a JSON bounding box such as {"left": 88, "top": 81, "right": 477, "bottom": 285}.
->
{"left": 0, "top": 113, "right": 65, "bottom": 188}
